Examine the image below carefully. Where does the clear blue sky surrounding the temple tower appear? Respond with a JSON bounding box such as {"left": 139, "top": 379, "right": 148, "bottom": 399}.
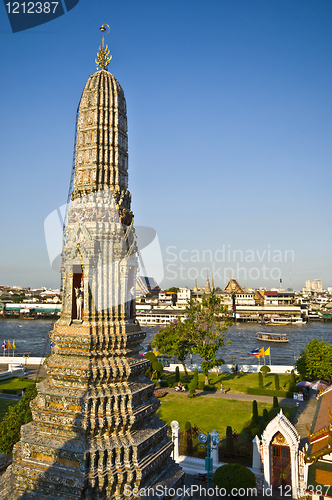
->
{"left": 0, "top": 0, "right": 332, "bottom": 289}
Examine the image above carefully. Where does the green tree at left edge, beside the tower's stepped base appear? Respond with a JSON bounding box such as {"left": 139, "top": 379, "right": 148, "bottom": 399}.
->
{"left": 0, "top": 384, "right": 37, "bottom": 455}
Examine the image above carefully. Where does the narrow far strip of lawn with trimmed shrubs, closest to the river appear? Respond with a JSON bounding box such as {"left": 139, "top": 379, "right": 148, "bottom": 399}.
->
{"left": 163, "top": 372, "right": 290, "bottom": 396}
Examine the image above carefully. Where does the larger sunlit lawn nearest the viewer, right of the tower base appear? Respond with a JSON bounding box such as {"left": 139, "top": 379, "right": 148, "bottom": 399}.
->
{"left": 157, "top": 389, "right": 272, "bottom": 436}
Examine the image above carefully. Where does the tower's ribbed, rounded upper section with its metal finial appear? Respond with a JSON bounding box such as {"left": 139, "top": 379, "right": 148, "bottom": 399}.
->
{"left": 72, "top": 24, "right": 132, "bottom": 224}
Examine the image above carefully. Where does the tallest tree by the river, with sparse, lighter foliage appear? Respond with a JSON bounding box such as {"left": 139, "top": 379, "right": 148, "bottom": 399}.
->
{"left": 186, "top": 293, "right": 232, "bottom": 385}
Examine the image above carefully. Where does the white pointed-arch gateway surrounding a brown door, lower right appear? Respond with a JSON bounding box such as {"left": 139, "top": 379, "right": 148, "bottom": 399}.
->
{"left": 261, "top": 410, "right": 300, "bottom": 498}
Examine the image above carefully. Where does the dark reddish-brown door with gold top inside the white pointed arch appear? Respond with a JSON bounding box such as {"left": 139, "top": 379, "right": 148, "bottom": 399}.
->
{"left": 271, "top": 432, "right": 292, "bottom": 488}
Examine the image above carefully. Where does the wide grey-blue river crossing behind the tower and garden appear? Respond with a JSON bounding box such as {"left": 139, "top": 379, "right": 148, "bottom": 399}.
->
{"left": 0, "top": 318, "right": 332, "bottom": 365}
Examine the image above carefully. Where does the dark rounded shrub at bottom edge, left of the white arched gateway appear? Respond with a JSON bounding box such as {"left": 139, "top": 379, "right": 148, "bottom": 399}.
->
{"left": 213, "top": 464, "right": 256, "bottom": 495}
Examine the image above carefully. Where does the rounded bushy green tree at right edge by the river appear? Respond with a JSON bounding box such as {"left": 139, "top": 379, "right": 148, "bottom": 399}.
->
{"left": 295, "top": 337, "right": 332, "bottom": 382}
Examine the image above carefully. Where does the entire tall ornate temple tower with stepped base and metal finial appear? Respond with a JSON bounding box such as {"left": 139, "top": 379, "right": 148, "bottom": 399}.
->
{"left": 3, "top": 26, "right": 183, "bottom": 500}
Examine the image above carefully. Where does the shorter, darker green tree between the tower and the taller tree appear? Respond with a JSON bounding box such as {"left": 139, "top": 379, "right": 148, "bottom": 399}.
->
{"left": 152, "top": 318, "right": 192, "bottom": 375}
